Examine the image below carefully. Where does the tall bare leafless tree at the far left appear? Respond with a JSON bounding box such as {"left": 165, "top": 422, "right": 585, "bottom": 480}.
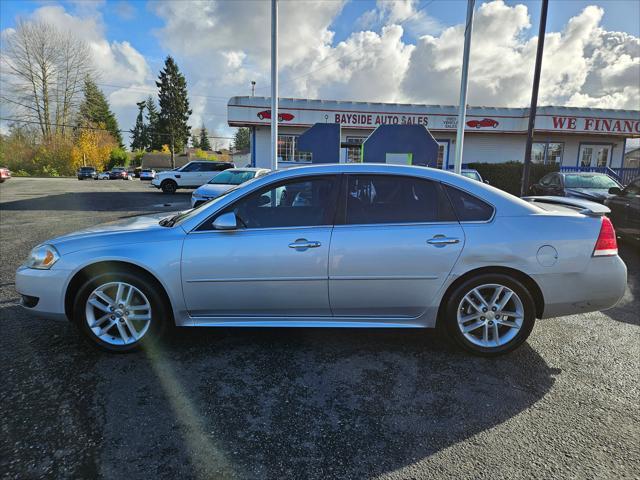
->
{"left": 0, "top": 21, "right": 93, "bottom": 139}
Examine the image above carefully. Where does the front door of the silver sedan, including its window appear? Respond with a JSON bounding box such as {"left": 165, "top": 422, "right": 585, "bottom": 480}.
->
{"left": 182, "top": 175, "right": 338, "bottom": 317}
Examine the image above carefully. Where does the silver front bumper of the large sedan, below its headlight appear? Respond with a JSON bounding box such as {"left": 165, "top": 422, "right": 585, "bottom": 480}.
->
{"left": 16, "top": 267, "right": 71, "bottom": 319}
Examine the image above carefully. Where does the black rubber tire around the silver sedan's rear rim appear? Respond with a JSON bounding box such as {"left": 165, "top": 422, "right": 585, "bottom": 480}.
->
{"left": 440, "top": 273, "right": 536, "bottom": 357}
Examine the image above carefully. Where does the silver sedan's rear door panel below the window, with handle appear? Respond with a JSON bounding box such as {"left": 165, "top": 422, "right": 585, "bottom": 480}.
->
{"left": 329, "top": 224, "right": 464, "bottom": 317}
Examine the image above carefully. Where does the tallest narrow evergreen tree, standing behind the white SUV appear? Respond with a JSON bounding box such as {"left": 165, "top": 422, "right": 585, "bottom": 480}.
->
{"left": 156, "top": 56, "right": 191, "bottom": 168}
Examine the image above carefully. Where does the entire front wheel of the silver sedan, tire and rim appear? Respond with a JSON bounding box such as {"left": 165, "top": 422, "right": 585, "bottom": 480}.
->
{"left": 73, "top": 271, "right": 170, "bottom": 353}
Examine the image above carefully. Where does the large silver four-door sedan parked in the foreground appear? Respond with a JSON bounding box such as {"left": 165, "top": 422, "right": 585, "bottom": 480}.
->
{"left": 16, "top": 164, "right": 626, "bottom": 355}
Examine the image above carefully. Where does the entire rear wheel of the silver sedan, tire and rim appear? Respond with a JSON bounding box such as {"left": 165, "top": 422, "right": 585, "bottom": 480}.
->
{"left": 444, "top": 274, "right": 536, "bottom": 356}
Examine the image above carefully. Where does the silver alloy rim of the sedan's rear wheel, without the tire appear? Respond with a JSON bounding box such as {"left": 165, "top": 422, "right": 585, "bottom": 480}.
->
{"left": 457, "top": 283, "right": 524, "bottom": 348}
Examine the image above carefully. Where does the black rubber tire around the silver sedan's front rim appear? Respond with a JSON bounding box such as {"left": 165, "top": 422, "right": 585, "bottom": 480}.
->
{"left": 73, "top": 271, "right": 172, "bottom": 353}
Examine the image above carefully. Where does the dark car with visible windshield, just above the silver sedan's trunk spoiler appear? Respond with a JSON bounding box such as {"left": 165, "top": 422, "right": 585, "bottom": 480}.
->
{"left": 531, "top": 172, "right": 622, "bottom": 203}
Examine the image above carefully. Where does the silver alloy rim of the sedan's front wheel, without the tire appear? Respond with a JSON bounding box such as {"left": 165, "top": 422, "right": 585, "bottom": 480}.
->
{"left": 85, "top": 282, "right": 151, "bottom": 345}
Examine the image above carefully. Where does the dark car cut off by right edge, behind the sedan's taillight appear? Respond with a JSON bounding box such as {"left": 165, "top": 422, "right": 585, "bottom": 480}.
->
{"left": 604, "top": 177, "right": 640, "bottom": 241}
